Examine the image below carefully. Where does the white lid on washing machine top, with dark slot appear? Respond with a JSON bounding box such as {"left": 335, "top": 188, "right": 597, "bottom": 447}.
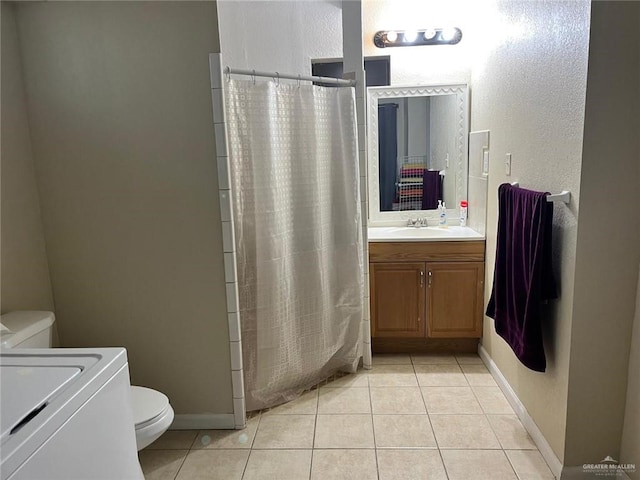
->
{"left": 0, "top": 365, "right": 82, "bottom": 438}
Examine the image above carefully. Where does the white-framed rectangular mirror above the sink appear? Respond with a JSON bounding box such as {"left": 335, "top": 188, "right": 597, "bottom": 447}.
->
{"left": 367, "top": 84, "right": 468, "bottom": 226}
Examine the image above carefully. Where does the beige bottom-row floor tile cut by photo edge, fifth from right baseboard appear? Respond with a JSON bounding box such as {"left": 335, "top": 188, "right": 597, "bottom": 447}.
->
{"left": 242, "top": 450, "right": 312, "bottom": 480}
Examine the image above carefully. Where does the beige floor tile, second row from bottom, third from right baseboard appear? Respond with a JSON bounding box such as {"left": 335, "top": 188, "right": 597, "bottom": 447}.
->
{"left": 373, "top": 415, "right": 437, "bottom": 448}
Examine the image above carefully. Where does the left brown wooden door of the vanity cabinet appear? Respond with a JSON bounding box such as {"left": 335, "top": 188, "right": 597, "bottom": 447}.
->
{"left": 369, "top": 262, "right": 426, "bottom": 337}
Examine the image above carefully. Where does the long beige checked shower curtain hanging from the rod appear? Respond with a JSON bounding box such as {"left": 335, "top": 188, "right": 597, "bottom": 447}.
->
{"left": 226, "top": 79, "right": 364, "bottom": 411}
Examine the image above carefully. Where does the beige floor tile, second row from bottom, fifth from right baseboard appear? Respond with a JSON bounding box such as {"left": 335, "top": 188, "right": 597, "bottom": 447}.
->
{"left": 253, "top": 415, "right": 316, "bottom": 449}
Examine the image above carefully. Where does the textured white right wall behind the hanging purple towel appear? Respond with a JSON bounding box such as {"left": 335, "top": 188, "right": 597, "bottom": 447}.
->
{"left": 471, "top": 1, "right": 601, "bottom": 461}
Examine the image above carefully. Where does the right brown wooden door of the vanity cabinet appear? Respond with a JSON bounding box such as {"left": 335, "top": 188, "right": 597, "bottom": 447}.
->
{"left": 426, "top": 262, "right": 484, "bottom": 338}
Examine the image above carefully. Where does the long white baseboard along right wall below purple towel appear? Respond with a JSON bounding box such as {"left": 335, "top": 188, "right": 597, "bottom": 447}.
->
{"left": 478, "top": 345, "right": 564, "bottom": 479}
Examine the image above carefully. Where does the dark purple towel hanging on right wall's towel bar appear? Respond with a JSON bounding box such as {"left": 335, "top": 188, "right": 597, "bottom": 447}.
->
{"left": 487, "top": 183, "right": 556, "bottom": 372}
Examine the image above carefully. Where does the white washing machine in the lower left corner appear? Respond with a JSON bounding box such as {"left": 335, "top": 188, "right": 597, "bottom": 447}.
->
{"left": 0, "top": 348, "right": 144, "bottom": 480}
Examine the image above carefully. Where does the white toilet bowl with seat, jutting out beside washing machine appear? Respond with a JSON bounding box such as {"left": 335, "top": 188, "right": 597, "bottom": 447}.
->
{"left": 131, "top": 386, "right": 173, "bottom": 450}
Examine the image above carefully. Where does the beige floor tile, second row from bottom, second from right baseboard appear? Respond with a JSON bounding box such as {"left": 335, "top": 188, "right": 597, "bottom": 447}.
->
{"left": 429, "top": 415, "right": 500, "bottom": 449}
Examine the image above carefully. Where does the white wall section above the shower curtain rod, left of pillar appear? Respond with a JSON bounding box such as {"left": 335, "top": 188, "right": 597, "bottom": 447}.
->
{"left": 218, "top": 0, "right": 342, "bottom": 75}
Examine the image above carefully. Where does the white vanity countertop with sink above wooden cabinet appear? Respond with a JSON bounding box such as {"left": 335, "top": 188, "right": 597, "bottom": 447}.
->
{"left": 367, "top": 226, "right": 484, "bottom": 242}
